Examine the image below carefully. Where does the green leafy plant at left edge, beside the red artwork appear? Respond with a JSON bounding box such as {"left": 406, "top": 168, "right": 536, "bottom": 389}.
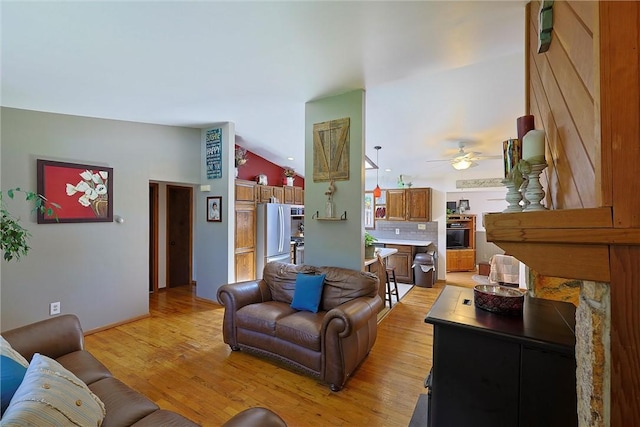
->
{"left": 0, "top": 188, "right": 60, "bottom": 261}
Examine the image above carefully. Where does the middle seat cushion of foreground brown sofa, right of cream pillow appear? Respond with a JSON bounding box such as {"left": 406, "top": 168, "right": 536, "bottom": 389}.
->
{"left": 89, "top": 377, "right": 159, "bottom": 427}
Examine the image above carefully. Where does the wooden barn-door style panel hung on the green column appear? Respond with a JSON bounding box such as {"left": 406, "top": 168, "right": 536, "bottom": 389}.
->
{"left": 313, "top": 117, "right": 350, "bottom": 182}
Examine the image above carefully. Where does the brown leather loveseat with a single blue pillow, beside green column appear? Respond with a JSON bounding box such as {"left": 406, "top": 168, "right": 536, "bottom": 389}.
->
{"left": 218, "top": 262, "right": 382, "bottom": 391}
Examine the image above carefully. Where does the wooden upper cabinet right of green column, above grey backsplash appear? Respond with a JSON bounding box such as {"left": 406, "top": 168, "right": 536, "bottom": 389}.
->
{"left": 385, "top": 188, "right": 431, "bottom": 222}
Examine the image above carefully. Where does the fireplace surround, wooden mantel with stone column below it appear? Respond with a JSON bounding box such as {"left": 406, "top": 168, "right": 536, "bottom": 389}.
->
{"left": 484, "top": 208, "right": 619, "bottom": 427}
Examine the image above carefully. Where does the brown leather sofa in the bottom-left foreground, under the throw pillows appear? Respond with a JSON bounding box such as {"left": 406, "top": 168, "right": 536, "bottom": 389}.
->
{"left": 2, "top": 314, "right": 286, "bottom": 427}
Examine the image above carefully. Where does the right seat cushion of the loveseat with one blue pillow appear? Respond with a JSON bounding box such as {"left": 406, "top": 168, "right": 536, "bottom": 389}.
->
{"left": 276, "top": 311, "right": 327, "bottom": 351}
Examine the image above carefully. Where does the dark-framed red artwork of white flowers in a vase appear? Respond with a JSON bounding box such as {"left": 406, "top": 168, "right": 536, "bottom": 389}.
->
{"left": 37, "top": 159, "right": 113, "bottom": 224}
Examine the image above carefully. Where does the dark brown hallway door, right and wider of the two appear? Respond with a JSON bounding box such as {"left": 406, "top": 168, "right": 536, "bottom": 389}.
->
{"left": 167, "top": 185, "right": 193, "bottom": 288}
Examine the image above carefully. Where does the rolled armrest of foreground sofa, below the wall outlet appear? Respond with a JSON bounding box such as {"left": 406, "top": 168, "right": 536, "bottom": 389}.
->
{"left": 2, "top": 314, "right": 84, "bottom": 361}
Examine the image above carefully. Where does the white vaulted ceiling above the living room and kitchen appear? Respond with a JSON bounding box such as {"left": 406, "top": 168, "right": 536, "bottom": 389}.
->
{"left": 1, "top": 1, "right": 526, "bottom": 186}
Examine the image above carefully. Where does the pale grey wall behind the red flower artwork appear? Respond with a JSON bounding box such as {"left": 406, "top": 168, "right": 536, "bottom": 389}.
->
{"left": 0, "top": 108, "right": 200, "bottom": 330}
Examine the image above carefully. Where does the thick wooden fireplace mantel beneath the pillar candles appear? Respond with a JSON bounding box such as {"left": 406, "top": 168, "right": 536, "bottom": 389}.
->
{"left": 483, "top": 207, "right": 640, "bottom": 282}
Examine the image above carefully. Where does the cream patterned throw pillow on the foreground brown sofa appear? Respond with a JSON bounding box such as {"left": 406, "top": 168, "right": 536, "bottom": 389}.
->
{"left": 2, "top": 353, "right": 105, "bottom": 426}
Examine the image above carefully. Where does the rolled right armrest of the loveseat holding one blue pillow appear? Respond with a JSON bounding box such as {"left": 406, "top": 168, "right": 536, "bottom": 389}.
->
{"left": 322, "top": 295, "right": 382, "bottom": 338}
